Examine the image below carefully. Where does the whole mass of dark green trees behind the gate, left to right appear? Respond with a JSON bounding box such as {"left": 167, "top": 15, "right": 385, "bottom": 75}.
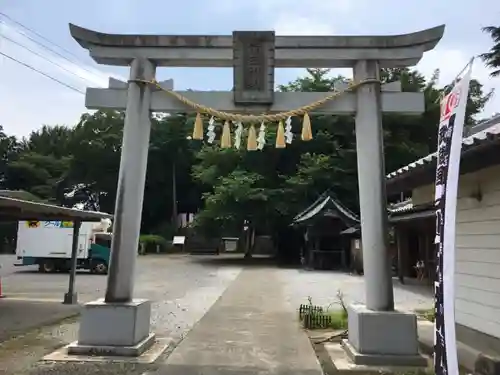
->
{"left": 0, "top": 69, "right": 491, "bottom": 241}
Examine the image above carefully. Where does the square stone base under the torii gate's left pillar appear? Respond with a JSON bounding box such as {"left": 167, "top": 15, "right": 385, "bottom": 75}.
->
{"left": 68, "top": 299, "right": 155, "bottom": 357}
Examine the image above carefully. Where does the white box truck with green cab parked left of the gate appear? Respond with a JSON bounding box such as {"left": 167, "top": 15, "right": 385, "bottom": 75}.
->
{"left": 16, "top": 220, "right": 111, "bottom": 274}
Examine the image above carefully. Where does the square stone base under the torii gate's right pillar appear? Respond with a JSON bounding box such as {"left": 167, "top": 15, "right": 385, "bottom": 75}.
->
{"left": 342, "top": 304, "right": 427, "bottom": 367}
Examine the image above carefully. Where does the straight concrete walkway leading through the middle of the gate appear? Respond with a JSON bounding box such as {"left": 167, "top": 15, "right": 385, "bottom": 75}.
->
{"left": 154, "top": 268, "right": 322, "bottom": 375}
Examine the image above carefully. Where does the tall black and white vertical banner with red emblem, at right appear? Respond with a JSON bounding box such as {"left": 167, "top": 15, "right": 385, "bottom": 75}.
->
{"left": 434, "top": 61, "right": 472, "bottom": 375}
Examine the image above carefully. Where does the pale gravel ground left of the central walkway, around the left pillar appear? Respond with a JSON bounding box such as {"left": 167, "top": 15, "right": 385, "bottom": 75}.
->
{"left": 0, "top": 255, "right": 241, "bottom": 375}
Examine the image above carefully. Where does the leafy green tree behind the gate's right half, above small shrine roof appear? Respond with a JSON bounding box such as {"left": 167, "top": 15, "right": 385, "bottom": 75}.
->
{"left": 193, "top": 68, "right": 491, "bottom": 239}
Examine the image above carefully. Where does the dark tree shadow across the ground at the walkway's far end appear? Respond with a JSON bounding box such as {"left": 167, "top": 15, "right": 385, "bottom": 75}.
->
{"left": 190, "top": 254, "right": 299, "bottom": 269}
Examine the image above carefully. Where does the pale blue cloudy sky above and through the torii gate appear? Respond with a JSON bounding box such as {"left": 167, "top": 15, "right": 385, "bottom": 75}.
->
{"left": 0, "top": 0, "right": 500, "bottom": 137}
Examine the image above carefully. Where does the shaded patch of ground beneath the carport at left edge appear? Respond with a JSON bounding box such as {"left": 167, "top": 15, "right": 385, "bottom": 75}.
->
{"left": 0, "top": 298, "right": 80, "bottom": 342}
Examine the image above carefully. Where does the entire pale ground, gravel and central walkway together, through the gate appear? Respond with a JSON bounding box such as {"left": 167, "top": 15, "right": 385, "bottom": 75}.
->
{"left": 0, "top": 255, "right": 432, "bottom": 375}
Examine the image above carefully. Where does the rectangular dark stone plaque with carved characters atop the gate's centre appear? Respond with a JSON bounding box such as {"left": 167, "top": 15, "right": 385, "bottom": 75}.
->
{"left": 233, "top": 31, "right": 274, "bottom": 105}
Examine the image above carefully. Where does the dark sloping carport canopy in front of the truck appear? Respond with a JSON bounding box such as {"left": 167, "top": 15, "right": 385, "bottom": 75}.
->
{"left": 0, "top": 196, "right": 113, "bottom": 222}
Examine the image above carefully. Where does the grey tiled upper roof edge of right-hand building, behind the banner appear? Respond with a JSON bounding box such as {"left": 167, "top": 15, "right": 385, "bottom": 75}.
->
{"left": 386, "top": 123, "right": 500, "bottom": 181}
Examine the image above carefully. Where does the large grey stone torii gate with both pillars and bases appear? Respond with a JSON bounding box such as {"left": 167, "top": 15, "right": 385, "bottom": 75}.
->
{"left": 69, "top": 25, "right": 444, "bottom": 365}
